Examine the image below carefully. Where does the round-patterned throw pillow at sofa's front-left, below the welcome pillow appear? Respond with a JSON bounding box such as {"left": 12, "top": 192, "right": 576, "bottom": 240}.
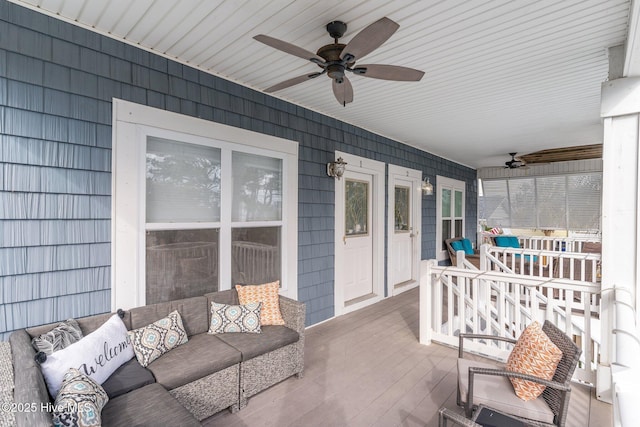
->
{"left": 53, "top": 368, "right": 109, "bottom": 427}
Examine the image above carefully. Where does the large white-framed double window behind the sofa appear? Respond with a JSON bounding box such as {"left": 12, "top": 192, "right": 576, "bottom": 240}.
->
{"left": 112, "top": 101, "right": 297, "bottom": 308}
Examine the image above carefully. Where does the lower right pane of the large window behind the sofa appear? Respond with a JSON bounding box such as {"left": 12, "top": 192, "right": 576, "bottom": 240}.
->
{"left": 231, "top": 227, "right": 281, "bottom": 285}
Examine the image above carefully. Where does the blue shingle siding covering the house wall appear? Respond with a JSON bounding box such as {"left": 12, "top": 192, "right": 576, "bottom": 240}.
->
{"left": 0, "top": 0, "right": 476, "bottom": 339}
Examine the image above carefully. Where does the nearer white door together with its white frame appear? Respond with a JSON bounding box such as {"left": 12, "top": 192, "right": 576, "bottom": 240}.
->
{"left": 334, "top": 152, "right": 385, "bottom": 315}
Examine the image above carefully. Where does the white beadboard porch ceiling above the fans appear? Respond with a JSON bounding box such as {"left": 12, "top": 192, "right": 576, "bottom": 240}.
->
{"left": 13, "top": 0, "right": 631, "bottom": 168}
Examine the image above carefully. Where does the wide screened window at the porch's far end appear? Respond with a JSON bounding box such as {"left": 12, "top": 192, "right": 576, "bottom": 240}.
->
{"left": 479, "top": 172, "right": 602, "bottom": 232}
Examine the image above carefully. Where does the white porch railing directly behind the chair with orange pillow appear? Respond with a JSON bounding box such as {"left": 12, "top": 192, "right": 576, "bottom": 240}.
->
{"left": 420, "top": 261, "right": 600, "bottom": 384}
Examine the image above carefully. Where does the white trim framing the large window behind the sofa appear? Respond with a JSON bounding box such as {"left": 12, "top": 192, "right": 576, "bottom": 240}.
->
{"left": 111, "top": 99, "right": 298, "bottom": 310}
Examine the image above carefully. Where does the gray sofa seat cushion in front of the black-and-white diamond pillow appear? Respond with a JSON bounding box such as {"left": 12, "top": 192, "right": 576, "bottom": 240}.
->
{"left": 147, "top": 333, "right": 242, "bottom": 390}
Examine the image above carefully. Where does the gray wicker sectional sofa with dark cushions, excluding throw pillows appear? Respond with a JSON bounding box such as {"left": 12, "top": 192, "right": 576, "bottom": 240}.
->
{"left": 9, "top": 290, "right": 305, "bottom": 427}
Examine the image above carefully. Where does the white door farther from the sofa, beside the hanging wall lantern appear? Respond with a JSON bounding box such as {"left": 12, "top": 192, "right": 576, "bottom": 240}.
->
{"left": 387, "top": 165, "right": 422, "bottom": 295}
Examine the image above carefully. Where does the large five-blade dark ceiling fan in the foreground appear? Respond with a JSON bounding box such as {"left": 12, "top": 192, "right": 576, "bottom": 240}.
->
{"left": 253, "top": 17, "right": 424, "bottom": 106}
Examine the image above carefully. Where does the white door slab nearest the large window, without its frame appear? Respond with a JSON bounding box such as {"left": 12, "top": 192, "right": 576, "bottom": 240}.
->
{"left": 342, "top": 171, "right": 374, "bottom": 304}
